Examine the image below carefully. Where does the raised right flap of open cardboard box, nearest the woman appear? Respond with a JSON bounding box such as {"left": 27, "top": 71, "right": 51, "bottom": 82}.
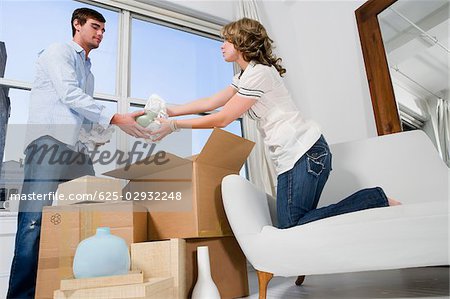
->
{"left": 194, "top": 129, "right": 255, "bottom": 171}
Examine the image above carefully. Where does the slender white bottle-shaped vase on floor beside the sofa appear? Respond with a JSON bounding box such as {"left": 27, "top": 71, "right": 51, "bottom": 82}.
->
{"left": 192, "top": 246, "right": 220, "bottom": 299}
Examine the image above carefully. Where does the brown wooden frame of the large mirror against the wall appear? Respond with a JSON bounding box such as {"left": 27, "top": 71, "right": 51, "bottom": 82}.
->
{"left": 355, "top": 0, "right": 402, "bottom": 135}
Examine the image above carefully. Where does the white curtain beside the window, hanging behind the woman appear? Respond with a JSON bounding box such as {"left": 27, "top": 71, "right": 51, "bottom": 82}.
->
{"left": 237, "top": 0, "right": 277, "bottom": 196}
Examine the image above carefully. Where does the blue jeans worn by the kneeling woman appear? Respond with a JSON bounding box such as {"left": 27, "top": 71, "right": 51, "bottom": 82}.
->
{"left": 277, "top": 136, "right": 389, "bottom": 228}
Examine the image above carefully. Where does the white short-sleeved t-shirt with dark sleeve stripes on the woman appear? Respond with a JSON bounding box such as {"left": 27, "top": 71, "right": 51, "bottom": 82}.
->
{"left": 231, "top": 61, "right": 321, "bottom": 175}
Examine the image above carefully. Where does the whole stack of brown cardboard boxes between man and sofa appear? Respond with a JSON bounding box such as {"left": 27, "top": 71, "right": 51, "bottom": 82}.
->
{"left": 36, "top": 129, "right": 254, "bottom": 298}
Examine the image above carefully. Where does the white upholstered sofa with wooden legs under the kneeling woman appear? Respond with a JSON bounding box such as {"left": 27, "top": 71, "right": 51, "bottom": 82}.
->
{"left": 222, "top": 131, "right": 450, "bottom": 298}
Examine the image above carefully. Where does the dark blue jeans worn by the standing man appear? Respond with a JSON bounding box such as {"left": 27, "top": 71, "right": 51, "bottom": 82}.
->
{"left": 7, "top": 136, "right": 95, "bottom": 299}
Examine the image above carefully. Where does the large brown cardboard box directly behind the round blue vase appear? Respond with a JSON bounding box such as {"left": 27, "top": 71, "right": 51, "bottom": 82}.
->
{"left": 36, "top": 202, "right": 147, "bottom": 298}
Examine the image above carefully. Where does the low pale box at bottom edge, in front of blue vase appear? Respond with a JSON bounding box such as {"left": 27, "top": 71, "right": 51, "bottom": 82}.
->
{"left": 53, "top": 277, "right": 173, "bottom": 299}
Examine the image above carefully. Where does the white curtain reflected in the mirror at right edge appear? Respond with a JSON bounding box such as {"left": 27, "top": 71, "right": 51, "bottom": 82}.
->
{"left": 427, "top": 94, "right": 450, "bottom": 167}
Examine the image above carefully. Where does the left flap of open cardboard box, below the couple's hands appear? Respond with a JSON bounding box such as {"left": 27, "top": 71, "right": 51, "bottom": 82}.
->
{"left": 104, "top": 153, "right": 192, "bottom": 180}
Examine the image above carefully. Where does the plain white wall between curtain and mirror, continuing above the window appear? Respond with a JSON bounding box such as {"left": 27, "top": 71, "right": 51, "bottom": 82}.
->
{"left": 158, "top": 0, "right": 377, "bottom": 143}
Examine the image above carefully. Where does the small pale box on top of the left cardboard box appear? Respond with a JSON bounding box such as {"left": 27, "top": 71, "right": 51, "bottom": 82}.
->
{"left": 53, "top": 175, "right": 125, "bottom": 206}
